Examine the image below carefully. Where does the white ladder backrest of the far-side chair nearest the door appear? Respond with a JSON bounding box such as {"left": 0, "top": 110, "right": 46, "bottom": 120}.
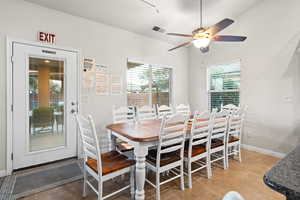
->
{"left": 112, "top": 106, "right": 135, "bottom": 123}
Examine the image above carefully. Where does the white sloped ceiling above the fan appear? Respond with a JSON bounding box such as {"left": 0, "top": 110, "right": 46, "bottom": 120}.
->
{"left": 26, "top": 0, "right": 261, "bottom": 44}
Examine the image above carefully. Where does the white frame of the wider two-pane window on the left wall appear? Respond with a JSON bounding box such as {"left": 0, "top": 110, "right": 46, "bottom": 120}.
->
{"left": 125, "top": 59, "right": 174, "bottom": 106}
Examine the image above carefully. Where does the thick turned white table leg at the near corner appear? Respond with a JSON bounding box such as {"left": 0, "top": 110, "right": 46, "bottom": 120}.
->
{"left": 134, "top": 145, "right": 148, "bottom": 200}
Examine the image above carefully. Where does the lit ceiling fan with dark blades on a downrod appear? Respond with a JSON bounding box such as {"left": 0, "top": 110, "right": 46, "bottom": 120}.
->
{"left": 167, "top": 0, "right": 247, "bottom": 53}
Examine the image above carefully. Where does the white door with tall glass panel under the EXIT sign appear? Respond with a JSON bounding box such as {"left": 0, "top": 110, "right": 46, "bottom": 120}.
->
{"left": 13, "top": 42, "right": 78, "bottom": 169}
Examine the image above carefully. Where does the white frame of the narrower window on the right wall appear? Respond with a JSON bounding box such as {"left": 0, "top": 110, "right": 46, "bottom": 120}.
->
{"left": 206, "top": 59, "right": 242, "bottom": 111}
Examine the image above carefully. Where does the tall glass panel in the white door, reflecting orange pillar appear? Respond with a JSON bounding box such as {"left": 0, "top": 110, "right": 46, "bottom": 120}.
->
{"left": 29, "top": 57, "right": 65, "bottom": 152}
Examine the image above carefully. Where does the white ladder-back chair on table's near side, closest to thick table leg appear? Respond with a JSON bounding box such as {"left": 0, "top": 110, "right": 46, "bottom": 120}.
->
{"left": 146, "top": 114, "right": 188, "bottom": 200}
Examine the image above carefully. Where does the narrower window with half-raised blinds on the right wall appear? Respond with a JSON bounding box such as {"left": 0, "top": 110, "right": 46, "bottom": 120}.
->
{"left": 207, "top": 62, "right": 241, "bottom": 110}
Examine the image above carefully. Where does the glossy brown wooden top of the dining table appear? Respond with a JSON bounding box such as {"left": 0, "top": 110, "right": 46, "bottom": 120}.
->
{"left": 106, "top": 120, "right": 196, "bottom": 142}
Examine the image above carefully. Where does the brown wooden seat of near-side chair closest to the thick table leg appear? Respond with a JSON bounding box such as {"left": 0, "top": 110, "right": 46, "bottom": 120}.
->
{"left": 146, "top": 149, "right": 180, "bottom": 167}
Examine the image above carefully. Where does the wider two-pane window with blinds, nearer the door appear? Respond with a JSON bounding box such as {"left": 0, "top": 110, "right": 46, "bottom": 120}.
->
{"left": 127, "top": 62, "right": 172, "bottom": 106}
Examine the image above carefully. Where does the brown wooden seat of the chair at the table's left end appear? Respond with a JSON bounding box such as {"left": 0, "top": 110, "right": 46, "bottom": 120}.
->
{"left": 86, "top": 151, "right": 135, "bottom": 176}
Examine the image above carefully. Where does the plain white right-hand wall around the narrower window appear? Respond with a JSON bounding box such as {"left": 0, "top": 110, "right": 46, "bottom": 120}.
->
{"left": 189, "top": 0, "right": 300, "bottom": 153}
